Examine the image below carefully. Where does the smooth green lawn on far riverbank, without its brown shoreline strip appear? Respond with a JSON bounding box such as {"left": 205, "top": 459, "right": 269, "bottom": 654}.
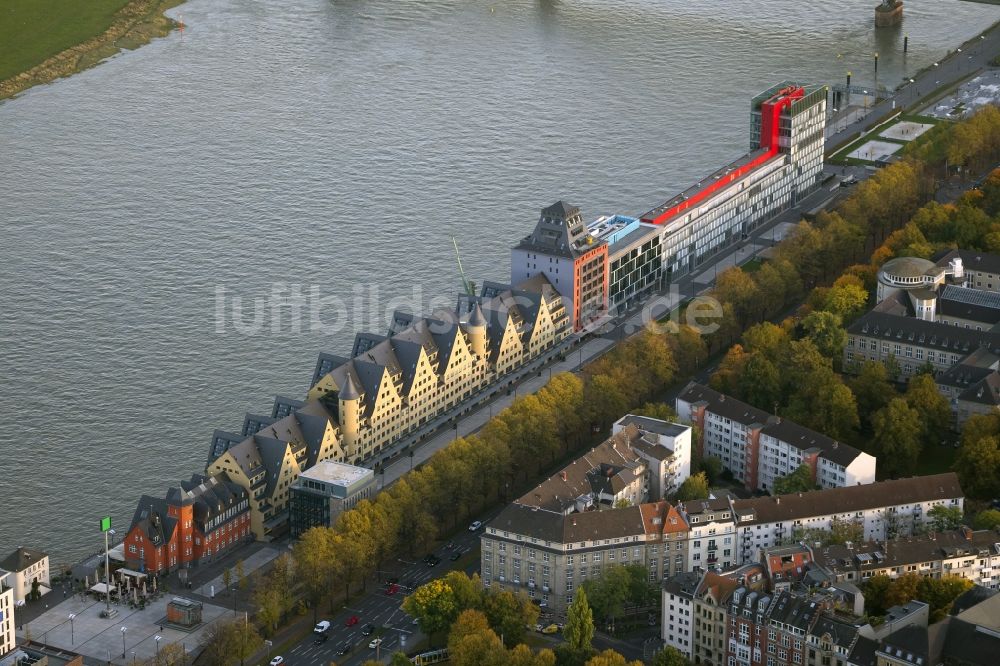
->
{"left": 0, "top": 0, "right": 128, "bottom": 81}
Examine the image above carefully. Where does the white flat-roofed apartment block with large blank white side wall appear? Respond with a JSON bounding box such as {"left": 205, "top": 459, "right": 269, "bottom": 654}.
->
{"left": 611, "top": 414, "right": 691, "bottom": 500}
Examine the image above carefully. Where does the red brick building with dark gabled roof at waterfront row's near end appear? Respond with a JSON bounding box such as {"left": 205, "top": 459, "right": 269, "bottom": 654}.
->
{"left": 125, "top": 474, "right": 252, "bottom": 573}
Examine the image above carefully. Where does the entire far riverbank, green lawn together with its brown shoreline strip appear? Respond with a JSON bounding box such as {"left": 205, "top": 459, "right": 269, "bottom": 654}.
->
{"left": 0, "top": 0, "right": 183, "bottom": 99}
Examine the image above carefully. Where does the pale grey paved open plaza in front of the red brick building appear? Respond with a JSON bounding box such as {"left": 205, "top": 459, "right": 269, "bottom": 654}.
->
{"left": 17, "top": 594, "right": 232, "bottom": 664}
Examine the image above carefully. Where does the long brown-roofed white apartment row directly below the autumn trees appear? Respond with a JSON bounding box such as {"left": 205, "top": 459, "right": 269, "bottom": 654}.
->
{"left": 676, "top": 382, "right": 875, "bottom": 490}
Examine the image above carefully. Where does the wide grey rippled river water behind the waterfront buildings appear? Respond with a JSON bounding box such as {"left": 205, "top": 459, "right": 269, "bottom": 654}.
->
{"left": 0, "top": 0, "right": 1000, "bottom": 562}
